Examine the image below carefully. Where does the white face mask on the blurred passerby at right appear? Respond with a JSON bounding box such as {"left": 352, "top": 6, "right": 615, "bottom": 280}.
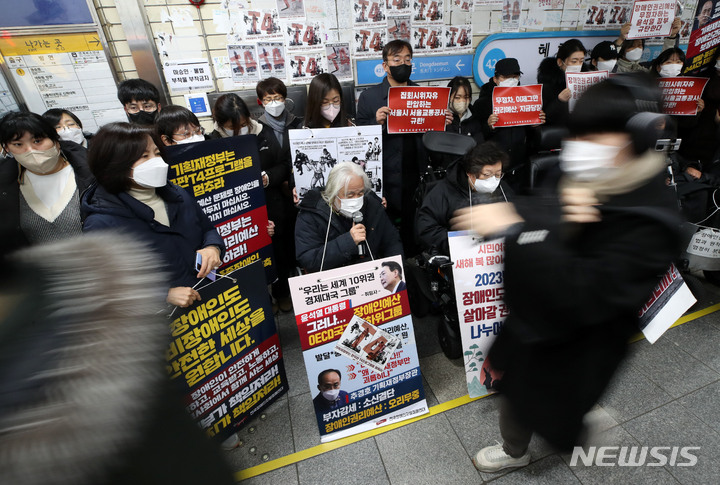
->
{"left": 560, "top": 140, "right": 624, "bottom": 182}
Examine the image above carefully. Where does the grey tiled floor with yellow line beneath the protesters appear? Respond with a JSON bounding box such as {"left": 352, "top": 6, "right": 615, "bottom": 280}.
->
{"left": 227, "top": 276, "right": 720, "bottom": 485}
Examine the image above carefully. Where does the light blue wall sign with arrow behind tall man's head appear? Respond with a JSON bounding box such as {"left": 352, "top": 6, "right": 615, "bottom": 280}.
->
{"left": 356, "top": 54, "right": 473, "bottom": 86}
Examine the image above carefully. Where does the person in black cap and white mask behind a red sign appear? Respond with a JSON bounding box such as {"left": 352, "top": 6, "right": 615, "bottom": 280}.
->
{"left": 473, "top": 57, "right": 545, "bottom": 185}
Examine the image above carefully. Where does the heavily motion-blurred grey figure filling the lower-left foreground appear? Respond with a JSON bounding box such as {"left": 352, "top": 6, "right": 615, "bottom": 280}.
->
{"left": 0, "top": 233, "right": 234, "bottom": 485}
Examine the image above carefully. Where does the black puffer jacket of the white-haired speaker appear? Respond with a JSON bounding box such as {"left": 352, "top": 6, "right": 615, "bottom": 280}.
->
{"left": 295, "top": 189, "right": 403, "bottom": 273}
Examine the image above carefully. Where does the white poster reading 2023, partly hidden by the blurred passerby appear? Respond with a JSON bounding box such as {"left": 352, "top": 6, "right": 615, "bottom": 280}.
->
{"left": 448, "top": 231, "right": 508, "bottom": 398}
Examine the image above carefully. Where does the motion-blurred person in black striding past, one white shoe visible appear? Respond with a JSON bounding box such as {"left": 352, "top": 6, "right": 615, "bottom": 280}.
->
{"left": 453, "top": 75, "right": 681, "bottom": 472}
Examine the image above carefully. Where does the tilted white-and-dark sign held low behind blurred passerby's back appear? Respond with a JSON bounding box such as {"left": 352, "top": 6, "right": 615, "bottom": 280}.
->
{"left": 638, "top": 265, "right": 697, "bottom": 344}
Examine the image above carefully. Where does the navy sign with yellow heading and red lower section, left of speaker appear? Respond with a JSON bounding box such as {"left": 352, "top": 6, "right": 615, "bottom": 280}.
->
{"left": 165, "top": 135, "right": 276, "bottom": 283}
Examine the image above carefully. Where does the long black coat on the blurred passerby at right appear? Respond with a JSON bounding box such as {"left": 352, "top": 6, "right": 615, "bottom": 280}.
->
{"left": 489, "top": 167, "right": 680, "bottom": 449}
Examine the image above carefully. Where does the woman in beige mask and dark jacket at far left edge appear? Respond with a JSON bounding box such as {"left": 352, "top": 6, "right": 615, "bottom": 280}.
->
{"left": 0, "top": 111, "right": 93, "bottom": 248}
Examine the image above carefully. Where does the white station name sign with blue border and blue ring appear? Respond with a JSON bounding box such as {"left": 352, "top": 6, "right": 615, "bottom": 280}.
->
{"left": 472, "top": 30, "right": 618, "bottom": 86}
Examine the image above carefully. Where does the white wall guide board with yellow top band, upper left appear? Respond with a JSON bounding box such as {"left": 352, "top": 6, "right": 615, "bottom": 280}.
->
{"left": 0, "top": 32, "right": 127, "bottom": 132}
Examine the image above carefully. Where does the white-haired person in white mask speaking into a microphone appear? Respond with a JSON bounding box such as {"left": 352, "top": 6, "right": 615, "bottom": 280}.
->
{"left": 295, "top": 162, "right": 403, "bottom": 273}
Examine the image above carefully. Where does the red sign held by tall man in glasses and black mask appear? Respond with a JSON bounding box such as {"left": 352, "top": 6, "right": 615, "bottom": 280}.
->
{"left": 387, "top": 86, "right": 450, "bottom": 133}
